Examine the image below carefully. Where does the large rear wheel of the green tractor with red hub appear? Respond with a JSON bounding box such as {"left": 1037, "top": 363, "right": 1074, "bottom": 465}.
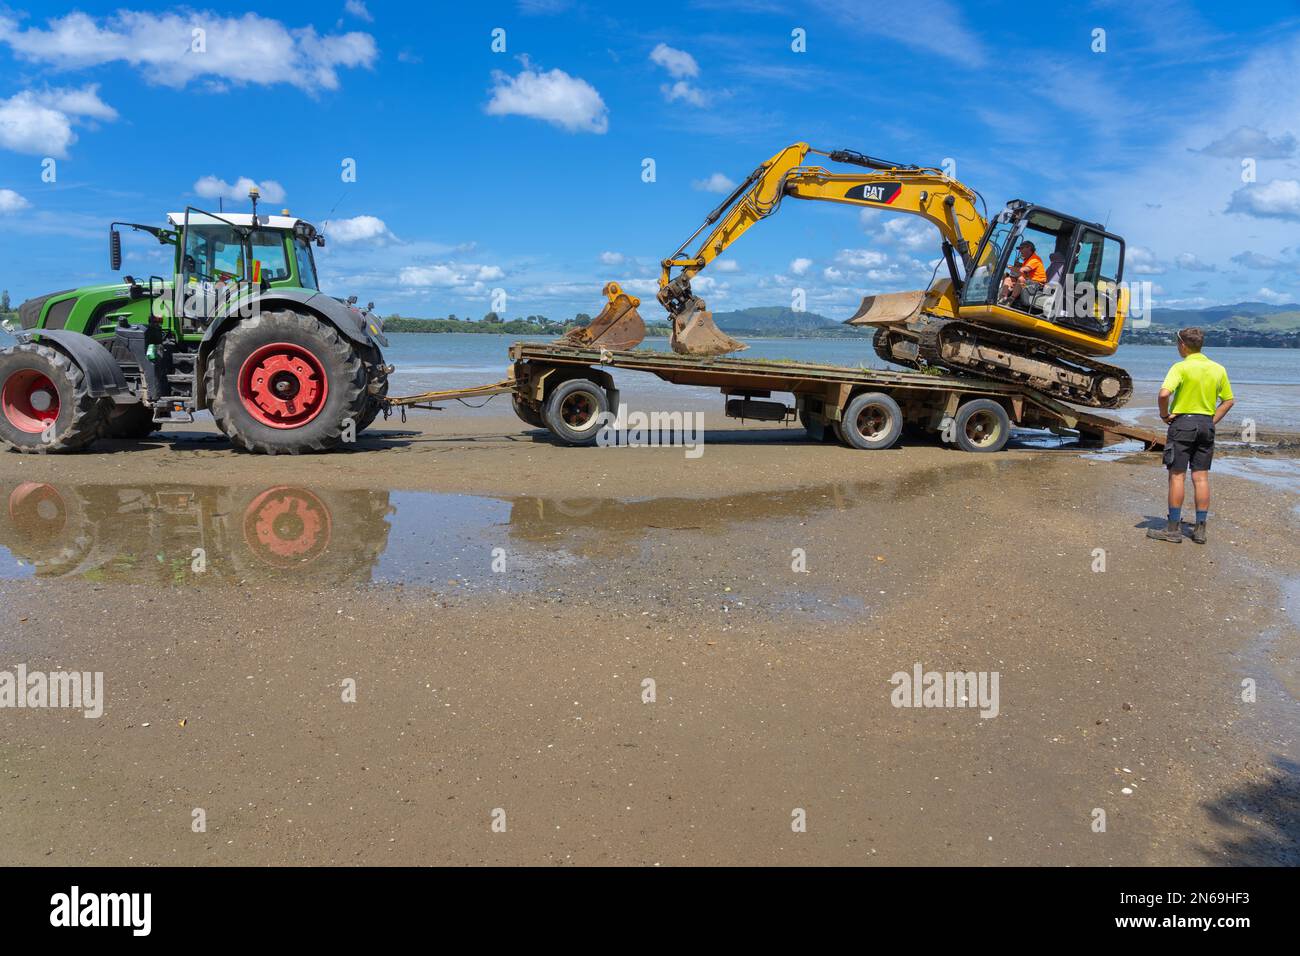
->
{"left": 204, "top": 312, "right": 366, "bottom": 455}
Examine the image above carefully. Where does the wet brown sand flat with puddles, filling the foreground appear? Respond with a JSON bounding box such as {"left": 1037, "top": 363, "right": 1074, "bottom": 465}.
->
{"left": 0, "top": 411, "right": 1300, "bottom": 865}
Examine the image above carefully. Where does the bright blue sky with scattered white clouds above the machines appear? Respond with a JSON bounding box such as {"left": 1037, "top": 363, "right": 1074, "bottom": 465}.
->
{"left": 0, "top": 0, "right": 1300, "bottom": 319}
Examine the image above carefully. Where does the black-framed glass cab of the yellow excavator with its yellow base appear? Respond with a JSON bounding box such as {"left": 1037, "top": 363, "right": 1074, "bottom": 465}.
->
{"left": 961, "top": 199, "right": 1125, "bottom": 351}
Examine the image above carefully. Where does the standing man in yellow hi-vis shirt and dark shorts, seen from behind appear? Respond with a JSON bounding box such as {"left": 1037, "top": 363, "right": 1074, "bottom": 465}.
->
{"left": 1147, "top": 329, "right": 1232, "bottom": 545}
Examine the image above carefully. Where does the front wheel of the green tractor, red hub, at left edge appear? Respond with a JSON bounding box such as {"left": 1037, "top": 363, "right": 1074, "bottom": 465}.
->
{"left": 0, "top": 342, "right": 104, "bottom": 455}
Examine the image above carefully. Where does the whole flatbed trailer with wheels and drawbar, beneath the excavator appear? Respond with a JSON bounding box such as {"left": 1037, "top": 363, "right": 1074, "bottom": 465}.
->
{"left": 389, "top": 342, "right": 1164, "bottom": 453}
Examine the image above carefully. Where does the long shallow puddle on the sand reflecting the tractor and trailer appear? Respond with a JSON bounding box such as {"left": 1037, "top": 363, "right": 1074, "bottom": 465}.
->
{"left": 0, "top": 459, "right": 1011, "bottom": 620}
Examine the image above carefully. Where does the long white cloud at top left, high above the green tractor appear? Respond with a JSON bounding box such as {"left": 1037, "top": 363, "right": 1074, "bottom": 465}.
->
{"left": 0, "top": 10, "right": 378, "bottom": 92}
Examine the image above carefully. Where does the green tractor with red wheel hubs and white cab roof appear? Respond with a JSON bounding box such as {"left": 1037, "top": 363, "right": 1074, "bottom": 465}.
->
{"left": 0, "top": 190, "right": 393, "bottom": 455}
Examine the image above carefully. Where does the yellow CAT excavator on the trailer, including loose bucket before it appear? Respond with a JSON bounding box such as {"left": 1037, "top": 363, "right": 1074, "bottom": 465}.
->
{"left": 568, "top": 143, "right": 1132, "bottom": 408}
